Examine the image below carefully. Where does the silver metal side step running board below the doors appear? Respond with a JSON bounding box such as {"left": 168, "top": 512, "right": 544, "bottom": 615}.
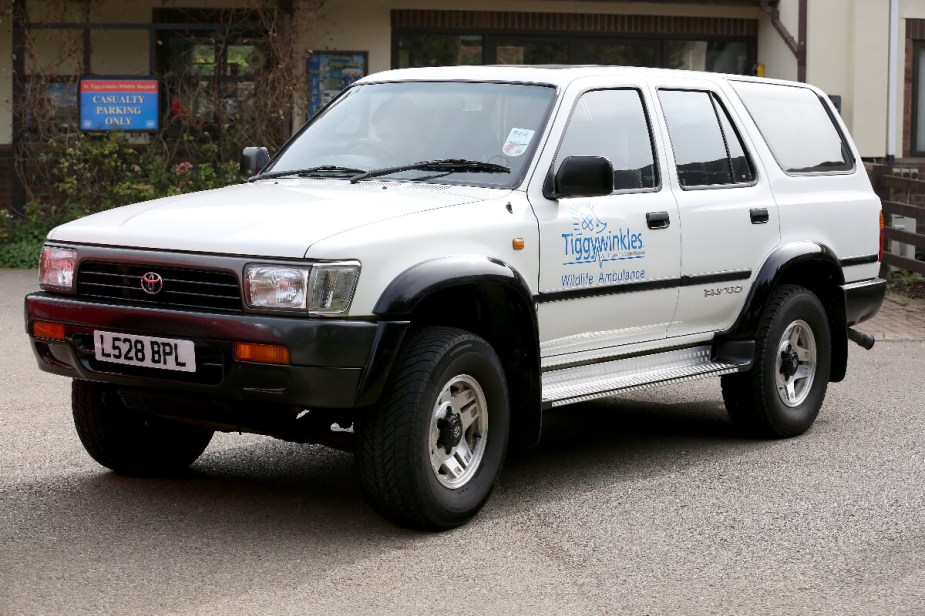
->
{"left": 543, "top": 345, "right": 751, "bottom": 407}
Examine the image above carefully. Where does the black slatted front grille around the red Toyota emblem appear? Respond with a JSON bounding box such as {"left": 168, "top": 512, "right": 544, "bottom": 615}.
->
{"left": 77, "top": 261, "right": 242, "bottom": 312}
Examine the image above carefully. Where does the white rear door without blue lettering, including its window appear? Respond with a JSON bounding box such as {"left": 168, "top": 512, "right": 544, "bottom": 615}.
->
{"left": 656, "top": 79, "right": 780, "bottom": 337}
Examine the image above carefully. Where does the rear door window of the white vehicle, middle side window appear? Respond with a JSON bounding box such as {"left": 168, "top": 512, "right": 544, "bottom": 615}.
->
{"left": 658, "top": 90, "right": 755, "bottom": 188}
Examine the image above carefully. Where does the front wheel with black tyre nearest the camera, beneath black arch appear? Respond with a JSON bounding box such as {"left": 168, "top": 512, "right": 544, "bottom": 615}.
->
{"left": 356, "top": 327, "right": 510, "bottom": 530}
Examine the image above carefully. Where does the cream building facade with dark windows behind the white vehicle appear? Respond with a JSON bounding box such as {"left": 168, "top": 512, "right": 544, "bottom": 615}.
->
{"left": 0, "top": 0, "right": 925, "bottom": 210}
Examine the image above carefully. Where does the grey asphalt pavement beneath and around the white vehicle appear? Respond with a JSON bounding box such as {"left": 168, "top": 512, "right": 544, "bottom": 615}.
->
{"left": 0, "top": 270, "right": 925, "bottom": 616}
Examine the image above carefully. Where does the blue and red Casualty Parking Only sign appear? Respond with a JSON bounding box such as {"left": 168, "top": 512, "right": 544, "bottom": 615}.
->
{"left": 78, "top": 77, "right": 160, "bottom": 132}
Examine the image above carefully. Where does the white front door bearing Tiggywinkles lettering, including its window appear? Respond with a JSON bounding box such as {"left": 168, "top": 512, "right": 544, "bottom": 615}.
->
{"left": 531, "top": 85, "right": 681, "bottom": 365}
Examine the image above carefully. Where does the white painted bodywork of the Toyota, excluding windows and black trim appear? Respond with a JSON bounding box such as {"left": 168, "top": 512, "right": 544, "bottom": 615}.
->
{"left": 50, "top": 66, "right": 879, "bottom": 378}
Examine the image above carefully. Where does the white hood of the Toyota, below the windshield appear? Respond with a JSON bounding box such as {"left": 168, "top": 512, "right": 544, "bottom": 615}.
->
{"left": 48, "top": 179, "right": 510, "bottom": 258}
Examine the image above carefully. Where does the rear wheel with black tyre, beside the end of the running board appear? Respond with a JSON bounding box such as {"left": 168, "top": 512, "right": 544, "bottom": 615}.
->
{"left": 722, "top": 285, "right": 832, "bottom": 438}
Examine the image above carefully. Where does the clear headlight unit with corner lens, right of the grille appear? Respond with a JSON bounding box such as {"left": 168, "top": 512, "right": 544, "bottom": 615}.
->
{"left": 244, "top": 261, "right": 360, "bottom": 315}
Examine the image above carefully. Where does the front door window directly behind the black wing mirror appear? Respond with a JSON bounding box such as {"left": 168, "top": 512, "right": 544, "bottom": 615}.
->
{"left": 556, "top": 90, "right": 658, "bottom": 190}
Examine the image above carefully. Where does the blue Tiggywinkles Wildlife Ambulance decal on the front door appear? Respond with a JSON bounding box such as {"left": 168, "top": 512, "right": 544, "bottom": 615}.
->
{"left": 562, "top": 203, "right": 646, "bottom": 287}
